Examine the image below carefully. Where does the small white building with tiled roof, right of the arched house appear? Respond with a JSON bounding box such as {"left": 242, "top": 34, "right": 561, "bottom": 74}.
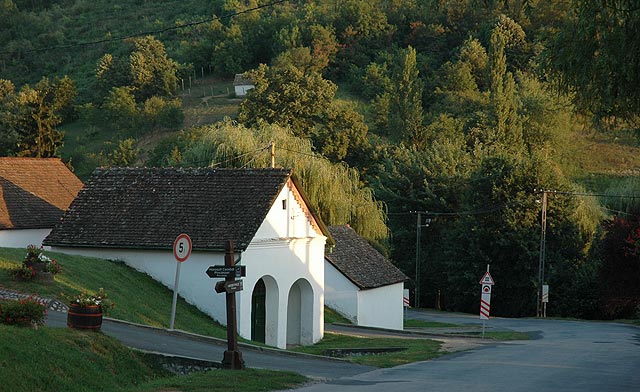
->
{"left": 324, "top": 226, "right": 408, "bottom": 330}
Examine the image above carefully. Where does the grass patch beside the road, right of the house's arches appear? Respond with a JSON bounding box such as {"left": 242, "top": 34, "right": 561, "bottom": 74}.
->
{"left": 292, "top": 332, "right": 446, "bottom": 368}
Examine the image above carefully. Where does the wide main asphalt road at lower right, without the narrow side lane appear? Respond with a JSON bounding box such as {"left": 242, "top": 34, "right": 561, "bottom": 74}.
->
{"left": 296, "top": 312, "right": 640, "bottom": 392}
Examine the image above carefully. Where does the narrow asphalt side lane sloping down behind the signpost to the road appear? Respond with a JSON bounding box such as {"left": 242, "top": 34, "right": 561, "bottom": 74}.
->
{"left": 47, "top": 311, "right": 374, "bottom": 379}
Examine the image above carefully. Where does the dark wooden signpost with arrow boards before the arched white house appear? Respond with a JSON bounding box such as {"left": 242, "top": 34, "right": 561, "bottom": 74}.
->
{"left": 206, "top": 241, "right": 246, "bottom": 369}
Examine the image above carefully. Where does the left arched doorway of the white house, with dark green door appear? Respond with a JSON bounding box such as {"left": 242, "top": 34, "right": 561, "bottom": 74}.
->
{"left": 251, "top": 275, "right": 279, "bottom": 346}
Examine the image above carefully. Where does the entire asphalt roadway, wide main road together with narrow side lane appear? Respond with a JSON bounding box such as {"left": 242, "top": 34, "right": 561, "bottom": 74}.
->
{"left": 47, "top": 311, "right": 640, "bottom": 392}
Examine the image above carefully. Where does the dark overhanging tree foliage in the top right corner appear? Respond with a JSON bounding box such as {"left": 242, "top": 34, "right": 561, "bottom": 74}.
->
{"left": 546, "top": 0, "right": 640, "bottom": 119}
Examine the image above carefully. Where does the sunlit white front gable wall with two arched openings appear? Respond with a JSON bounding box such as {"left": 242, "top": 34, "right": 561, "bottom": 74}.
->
{"left": 238, "top": 184, "right": 326, "bottom": 348}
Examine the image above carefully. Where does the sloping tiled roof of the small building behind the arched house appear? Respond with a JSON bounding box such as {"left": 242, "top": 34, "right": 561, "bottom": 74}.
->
{"left": 325, "top": 226, "right": 408, "bottom": 289}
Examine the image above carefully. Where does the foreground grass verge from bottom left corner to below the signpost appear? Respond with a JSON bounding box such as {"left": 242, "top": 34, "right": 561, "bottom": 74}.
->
{"left": 0, "top": 325, "right": 307, "bottom": 392}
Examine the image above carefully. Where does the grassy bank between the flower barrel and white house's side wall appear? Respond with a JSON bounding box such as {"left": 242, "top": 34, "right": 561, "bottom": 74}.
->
{"left": 0, "top": 248, "right": 227, "bottom": 339}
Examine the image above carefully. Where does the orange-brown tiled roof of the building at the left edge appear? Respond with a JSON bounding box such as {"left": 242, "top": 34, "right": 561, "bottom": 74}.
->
{"left": 0, "top": 157, "right": 82, "bottom": 229}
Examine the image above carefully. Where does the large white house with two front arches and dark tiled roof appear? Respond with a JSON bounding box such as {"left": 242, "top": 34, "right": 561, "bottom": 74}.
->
{"left": 44, "top": 168, "right": 331, "bottom": 348}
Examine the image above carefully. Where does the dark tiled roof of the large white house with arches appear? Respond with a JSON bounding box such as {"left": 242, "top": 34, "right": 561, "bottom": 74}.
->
{"left": 44, "top": 168, "right": 314, "bottom": 250}
